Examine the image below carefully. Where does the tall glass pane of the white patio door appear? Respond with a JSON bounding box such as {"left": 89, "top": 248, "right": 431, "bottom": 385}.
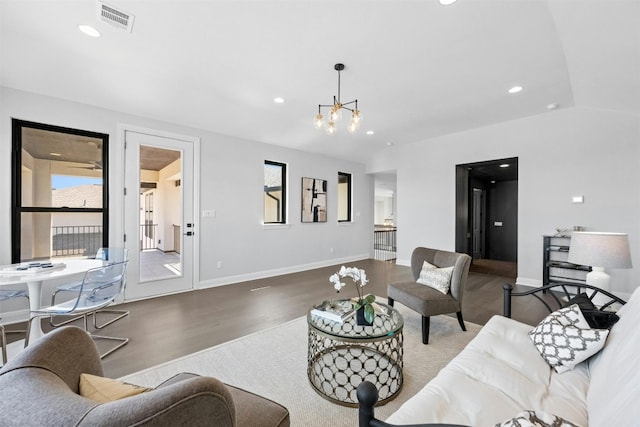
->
{"left": 138, "top": 145, "right": 183, "bottom": 283}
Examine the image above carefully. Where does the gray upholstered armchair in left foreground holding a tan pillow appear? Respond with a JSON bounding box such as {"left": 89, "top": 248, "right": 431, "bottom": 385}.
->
{"left": 0, "top": 326, "right": 289, "bottom": 427}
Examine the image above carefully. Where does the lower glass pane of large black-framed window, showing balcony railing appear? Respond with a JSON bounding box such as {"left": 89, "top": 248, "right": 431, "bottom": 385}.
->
{"left": 20, "top": 212, "right": 102, "bottom": 261}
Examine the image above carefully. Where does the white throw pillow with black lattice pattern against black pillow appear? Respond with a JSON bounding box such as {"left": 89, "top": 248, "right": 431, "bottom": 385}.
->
{"left": 529, "top": 304, "right": 609, "bottom": 373}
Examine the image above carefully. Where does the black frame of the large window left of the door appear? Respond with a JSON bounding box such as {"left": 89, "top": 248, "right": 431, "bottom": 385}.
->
{"left": 11, "top": 119, "right": 109, "bottom": 263}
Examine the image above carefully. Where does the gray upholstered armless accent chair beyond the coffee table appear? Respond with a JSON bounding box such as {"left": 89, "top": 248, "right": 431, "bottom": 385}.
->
{"left": 387, "top": 247, "right": 471, "bottom": 344}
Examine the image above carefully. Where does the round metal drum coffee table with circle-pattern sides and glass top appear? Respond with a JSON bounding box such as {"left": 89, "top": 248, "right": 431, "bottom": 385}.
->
{"left": 307, "top": 300, "right": 404, "bottom": 407}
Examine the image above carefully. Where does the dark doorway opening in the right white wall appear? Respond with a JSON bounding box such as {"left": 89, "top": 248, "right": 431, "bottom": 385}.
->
{"left": 456, "top": 157, "right": 518, "bottom": 278}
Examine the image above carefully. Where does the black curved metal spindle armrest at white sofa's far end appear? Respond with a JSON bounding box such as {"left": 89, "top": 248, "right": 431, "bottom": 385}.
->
{"left": 502, "top": 282, "right": 626, "bottom": 317}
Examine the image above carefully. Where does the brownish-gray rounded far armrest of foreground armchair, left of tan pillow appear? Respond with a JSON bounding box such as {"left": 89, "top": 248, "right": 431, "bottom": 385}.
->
{"left": 2, "top": 326, "right": 103, "bottom": 393}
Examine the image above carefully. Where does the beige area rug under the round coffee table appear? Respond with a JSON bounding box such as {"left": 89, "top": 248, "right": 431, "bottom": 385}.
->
{"left": 121, "top": 304, "right": 480, "bottom": 427}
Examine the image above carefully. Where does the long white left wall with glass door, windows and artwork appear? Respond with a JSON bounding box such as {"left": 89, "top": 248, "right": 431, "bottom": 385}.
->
{"left": 0, "top": 87, "right": 373, "bottom": 287}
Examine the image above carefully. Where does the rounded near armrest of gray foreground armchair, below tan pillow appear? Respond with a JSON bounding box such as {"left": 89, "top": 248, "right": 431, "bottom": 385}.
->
{"left": 78, "top": 377, "right": 235, "bottom": 427}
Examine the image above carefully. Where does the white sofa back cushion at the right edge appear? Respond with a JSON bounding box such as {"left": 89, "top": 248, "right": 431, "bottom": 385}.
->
{"left": 587, "top": 288, "right": 640, "bottom": 426}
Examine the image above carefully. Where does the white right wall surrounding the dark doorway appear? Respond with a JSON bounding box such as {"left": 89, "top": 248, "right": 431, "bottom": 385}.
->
{"left": 368, "top": 108, "right": 640, "bottom": 295}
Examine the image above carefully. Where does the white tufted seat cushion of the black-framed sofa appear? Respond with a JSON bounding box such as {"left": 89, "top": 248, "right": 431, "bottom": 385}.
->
{"left": 386, "top": 316, "right": 589, "bottom": 426}
